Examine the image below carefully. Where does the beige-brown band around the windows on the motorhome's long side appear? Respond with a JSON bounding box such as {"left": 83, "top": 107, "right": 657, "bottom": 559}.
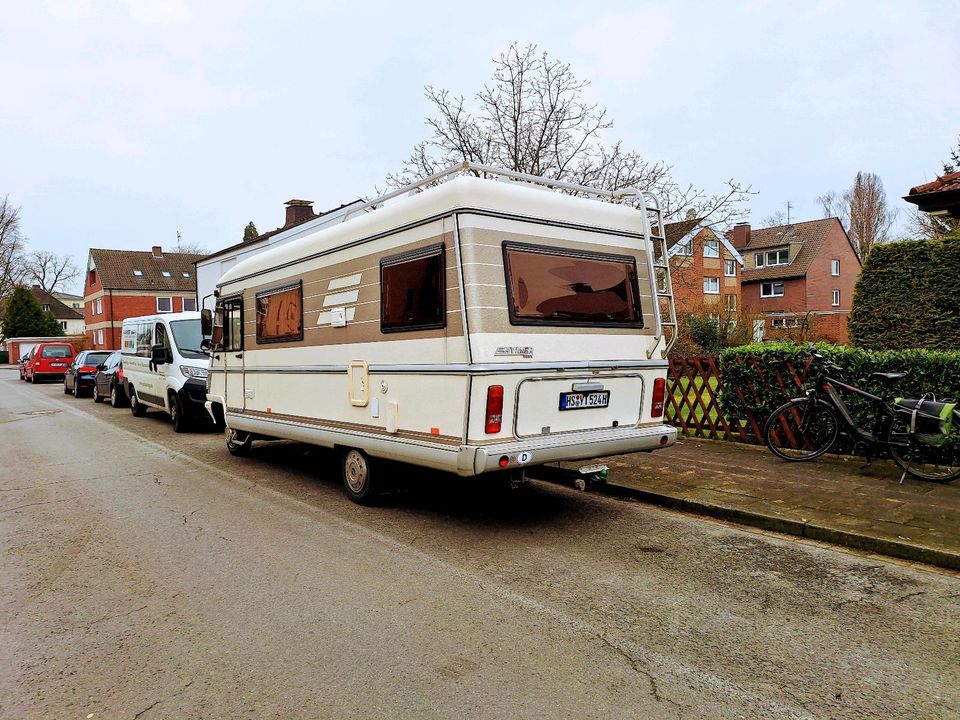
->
{"left": 243, "top": 232, "right": 464, "bottom": 349}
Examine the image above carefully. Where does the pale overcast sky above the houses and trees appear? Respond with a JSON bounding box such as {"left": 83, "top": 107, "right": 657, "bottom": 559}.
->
{"left": 0, "top": 0, "right": 960, "bottom": 290}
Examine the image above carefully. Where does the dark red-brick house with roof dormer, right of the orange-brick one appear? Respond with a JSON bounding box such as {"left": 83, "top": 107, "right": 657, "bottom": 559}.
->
{"left": 729, "top": 217, "right": 861, "bottom": 343}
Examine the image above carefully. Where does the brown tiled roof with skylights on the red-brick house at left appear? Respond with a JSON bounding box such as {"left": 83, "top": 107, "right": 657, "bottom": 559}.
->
{"left": 90, "top": 248, "right": 203, "bottom": 293}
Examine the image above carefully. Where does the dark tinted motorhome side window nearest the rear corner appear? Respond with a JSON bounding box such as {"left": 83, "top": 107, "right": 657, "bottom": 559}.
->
{"left": 380, "top": 245, "right": 447, "bottom": 332}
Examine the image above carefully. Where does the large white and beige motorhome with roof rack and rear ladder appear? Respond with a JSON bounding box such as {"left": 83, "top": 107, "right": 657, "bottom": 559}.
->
{"left": 207, "top": 163, "right": 676, "bottom": 502}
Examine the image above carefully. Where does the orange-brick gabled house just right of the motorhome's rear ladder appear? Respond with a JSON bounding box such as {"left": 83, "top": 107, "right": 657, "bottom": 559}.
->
{"left": 664, "top": 218, "right": 744, "bottom": 319}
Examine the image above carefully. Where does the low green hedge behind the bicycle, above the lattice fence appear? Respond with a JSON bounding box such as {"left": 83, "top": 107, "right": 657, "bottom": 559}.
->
{"left": 719, "top": 342, "right": 960, "bottom": 451}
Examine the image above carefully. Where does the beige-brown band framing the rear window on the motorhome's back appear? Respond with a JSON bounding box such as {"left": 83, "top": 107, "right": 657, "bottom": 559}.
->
{"left": 460, "top": 225, "right": 655, "bottom": 335}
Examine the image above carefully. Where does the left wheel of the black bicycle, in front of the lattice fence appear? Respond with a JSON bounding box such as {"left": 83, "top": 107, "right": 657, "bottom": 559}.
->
{"left": 763, "top": 398, "right": 840, "bottom": 462}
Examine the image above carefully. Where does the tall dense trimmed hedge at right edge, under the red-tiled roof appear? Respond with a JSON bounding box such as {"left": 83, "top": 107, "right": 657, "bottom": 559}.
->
{"left": 848, "top": 236, "right": 960, "bottom": 351}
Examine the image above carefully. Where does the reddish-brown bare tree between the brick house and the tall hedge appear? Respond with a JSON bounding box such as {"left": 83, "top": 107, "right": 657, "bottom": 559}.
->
{"left": 817, "top": 171, "right": 897, "bottom": 260}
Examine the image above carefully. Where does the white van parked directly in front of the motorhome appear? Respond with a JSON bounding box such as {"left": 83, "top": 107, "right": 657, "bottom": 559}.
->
{"left": 120, "top": 312, "right": 210, "bottom": 432}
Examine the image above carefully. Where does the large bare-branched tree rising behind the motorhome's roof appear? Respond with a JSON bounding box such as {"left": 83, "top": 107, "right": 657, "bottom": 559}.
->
{"left": 387, "top": 44, "right": 751, "bottom": 224}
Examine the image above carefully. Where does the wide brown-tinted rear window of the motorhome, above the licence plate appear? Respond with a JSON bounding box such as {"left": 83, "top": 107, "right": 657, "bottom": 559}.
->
{"left": 503, "top": 243, "right": 643, "bottom": 327}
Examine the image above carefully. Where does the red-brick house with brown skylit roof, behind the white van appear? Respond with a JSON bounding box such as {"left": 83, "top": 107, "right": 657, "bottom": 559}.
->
{"left": 83, "top": 246, "right": 203, "bottom": 349}
